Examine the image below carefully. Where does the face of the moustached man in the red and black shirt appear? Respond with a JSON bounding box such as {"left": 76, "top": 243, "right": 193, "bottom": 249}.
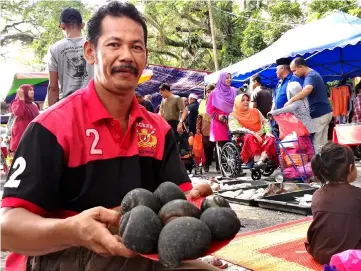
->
{"left": 84, "top": 16, "right": 148, "bottom": 94}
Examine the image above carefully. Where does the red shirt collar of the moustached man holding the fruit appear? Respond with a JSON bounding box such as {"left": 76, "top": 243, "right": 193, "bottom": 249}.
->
{"left": 85, "top": 79, "right": 143, "bottom": 123}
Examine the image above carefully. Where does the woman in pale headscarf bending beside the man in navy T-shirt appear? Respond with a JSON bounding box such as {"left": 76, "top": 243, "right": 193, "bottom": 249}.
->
{"left": 268, "top": 82, "right": 316, "bottom": 134}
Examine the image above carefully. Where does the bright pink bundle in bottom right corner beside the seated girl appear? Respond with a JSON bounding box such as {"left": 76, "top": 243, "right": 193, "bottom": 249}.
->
{"left": 330, "top": 249, "right": 361, "bottom": 271}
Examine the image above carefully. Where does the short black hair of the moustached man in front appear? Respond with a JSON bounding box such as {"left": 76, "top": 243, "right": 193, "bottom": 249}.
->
{"left": 87, "top": 1, "right": 148, "bottom": 47}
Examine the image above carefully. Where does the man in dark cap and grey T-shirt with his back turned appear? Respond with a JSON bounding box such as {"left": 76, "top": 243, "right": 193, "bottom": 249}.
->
{"left": 46, "top": 8, "right": 94, "bottom": 107}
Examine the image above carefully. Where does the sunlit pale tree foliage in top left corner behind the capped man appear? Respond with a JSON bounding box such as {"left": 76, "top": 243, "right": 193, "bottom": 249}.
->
{"left": 1, "top": 0, "right": 91, "bottom": 65}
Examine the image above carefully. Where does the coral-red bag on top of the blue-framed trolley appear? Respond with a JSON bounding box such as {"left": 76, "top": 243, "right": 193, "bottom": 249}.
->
{"left": 273, "top": 113, "right": 310, "bottom": 140}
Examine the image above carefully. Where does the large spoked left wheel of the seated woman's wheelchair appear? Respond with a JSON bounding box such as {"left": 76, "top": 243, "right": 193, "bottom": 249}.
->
{"left": 220, "top": 142, "right": 242, "bottom": 178}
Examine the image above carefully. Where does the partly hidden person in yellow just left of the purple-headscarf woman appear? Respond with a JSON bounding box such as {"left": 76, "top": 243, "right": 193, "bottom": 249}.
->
{"left": 196, "top": 84, "right": 215, "bottom": 172}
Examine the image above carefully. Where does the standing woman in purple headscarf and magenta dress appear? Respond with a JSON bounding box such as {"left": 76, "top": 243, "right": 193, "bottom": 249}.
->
{"left": 206, "top": 72, "right": 237, "bottom": 172}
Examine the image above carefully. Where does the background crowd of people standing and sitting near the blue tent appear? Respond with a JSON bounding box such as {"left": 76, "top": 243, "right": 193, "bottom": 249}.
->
{"left": 150, "top": 57, "right": 332, "bottom": 174}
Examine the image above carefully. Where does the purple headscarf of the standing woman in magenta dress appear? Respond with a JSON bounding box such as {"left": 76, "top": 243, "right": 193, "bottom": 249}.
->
{"left": 212, "top": 72, "right": 237, "bottom": 114}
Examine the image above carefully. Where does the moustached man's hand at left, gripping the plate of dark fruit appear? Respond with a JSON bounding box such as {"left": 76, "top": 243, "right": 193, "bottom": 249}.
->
{"left": 63, "top": 207, "right": 136, "bottom": 258}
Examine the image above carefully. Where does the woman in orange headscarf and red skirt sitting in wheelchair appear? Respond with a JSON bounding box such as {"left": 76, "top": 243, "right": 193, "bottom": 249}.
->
{"left": 228, "top": 94, "right": 278, "bottom": 169}
